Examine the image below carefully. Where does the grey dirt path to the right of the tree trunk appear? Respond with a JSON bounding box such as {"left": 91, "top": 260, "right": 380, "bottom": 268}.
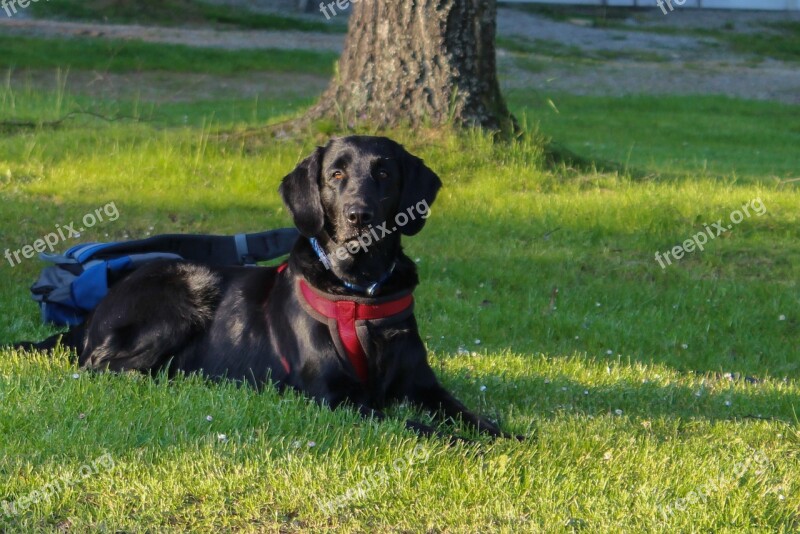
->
{"left": 498, "top": 9, "right": 800, "bottom": 104}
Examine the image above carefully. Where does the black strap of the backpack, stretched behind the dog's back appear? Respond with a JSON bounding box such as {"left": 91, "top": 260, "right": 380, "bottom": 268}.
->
{"left": 83, "top": 228, "right": 300, "bottom": 266}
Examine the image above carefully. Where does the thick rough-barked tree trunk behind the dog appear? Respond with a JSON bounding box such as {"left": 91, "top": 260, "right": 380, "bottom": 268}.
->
{"left": 309, "top": 0, "right": 516, "bottom": 132}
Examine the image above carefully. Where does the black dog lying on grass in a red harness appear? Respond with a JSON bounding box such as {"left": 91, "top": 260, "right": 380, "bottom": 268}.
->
{"left": 21, "top": 137, "right": 520, "bottom": 437}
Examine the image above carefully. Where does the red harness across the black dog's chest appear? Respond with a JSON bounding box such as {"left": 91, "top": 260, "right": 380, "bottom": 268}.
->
{"left": 298, "top": 278, "right": 414, "bottom": 384}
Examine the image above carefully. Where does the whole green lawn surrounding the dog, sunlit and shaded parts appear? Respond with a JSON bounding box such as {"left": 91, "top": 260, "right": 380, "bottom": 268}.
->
{"left": 0, "top": 35, "right": 800, "bottom": 532}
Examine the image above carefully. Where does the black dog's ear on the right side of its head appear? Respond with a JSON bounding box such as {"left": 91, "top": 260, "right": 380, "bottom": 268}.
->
{"left": 397, "top": 150, "right": 442, "bottom": 235}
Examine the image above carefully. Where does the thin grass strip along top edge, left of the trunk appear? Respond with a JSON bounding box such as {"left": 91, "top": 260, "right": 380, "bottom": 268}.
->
{"left": 31, "top": 0, "right": 347, "bottom": 33}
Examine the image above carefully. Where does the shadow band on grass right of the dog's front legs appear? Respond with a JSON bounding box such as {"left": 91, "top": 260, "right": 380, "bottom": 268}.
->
{"left": 437, "top": 370, "right": 800, "bottom": 432}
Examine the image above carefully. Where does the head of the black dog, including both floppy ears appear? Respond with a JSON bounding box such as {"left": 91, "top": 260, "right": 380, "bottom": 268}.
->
{"left": 280, "top": 136, "right": 442, "bottom": 272}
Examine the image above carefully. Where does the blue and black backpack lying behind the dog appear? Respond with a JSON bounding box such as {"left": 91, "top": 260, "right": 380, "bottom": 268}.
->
{"left": 31, "top": 228, "right": 299, "bottom": 326}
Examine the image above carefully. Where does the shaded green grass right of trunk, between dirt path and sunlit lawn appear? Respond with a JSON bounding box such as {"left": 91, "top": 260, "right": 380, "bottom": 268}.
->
{"left": 507, "top": 90, "right": 800, "bottom": 183}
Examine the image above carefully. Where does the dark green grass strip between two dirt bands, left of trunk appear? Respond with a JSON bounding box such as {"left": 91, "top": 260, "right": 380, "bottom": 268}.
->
{"left": 0, "top": 36, "right": 338, "bottom": 74}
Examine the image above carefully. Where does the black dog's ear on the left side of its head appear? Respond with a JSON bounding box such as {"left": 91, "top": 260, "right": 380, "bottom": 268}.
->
{"left": 280, "top": 147, "right": 325, "bottom": 238}
